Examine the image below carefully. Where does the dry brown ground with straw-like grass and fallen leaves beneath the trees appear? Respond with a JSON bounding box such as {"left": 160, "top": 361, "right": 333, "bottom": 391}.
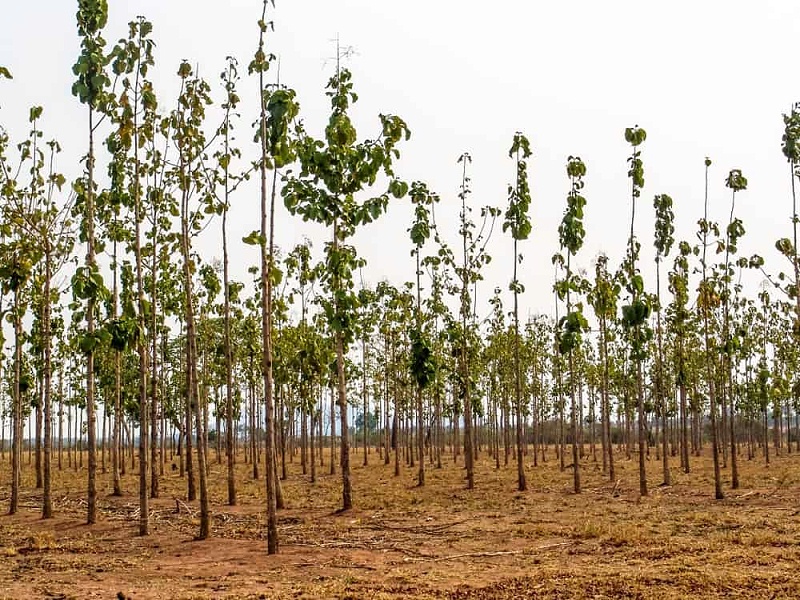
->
{"left": 0, "top": 442, "right": 800, "bottom": 600}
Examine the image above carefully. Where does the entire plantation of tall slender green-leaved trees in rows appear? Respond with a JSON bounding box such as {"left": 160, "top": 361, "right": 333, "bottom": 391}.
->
{"left": 0, "top": 0, "right": 800, "bottom": 553}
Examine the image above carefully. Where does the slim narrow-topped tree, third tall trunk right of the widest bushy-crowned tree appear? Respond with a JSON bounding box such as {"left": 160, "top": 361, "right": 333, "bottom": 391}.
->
{"left": 503, "top": 132, "right": 531, "bottom": 492}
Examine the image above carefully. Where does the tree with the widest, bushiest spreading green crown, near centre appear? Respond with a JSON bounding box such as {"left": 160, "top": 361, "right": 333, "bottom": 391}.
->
{"left": 283, "top": 62, "right": 410, "bottom": 510}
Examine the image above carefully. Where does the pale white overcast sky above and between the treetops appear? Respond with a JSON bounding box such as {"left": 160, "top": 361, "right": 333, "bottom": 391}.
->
{"left": 0, "top": 0, "right": 800, "bottom": 324}
